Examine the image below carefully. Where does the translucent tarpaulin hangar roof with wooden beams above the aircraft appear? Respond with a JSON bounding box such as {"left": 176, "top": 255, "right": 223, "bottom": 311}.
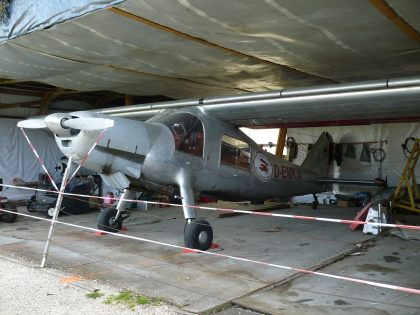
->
{"left": 0, "top": 0, "right": 420, "bottom": 126}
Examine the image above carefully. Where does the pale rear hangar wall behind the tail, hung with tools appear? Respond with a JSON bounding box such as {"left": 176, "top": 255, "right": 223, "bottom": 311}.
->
{"left": 287, "top": 123, "right": 420, "bottom": 191}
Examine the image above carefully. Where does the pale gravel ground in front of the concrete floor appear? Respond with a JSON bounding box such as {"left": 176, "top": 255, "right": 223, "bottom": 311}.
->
{"left": 0, "top": 256, "right": 184, "bottom": 315}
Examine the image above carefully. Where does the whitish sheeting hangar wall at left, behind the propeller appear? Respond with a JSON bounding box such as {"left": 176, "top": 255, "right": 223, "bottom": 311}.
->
{"left": 0, "top": 118, "right": 63, "bottom": 199}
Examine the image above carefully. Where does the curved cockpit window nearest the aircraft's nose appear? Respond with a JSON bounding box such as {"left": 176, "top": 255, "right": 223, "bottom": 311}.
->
{"left": 161, "top": 113, "right": 204, "bottom": 157}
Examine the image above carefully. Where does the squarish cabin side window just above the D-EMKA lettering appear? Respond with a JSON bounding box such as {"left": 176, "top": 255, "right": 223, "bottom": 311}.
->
{"left": 220, "top": 135, "right": 251, "bottom": 170}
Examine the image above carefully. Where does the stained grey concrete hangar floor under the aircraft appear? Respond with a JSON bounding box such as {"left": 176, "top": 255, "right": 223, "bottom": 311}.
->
{"left": 0, "top": 205, "right": 420, "bottom": 314}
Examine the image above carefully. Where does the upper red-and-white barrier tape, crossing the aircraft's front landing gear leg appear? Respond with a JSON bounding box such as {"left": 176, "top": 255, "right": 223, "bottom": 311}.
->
{"left": 0, "top": 184, "right": 420, "bottom": 231}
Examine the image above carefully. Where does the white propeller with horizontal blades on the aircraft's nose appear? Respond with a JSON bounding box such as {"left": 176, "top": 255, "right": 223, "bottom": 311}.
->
{"left": 17, "top": 113, "right": 114, "bottom": 137}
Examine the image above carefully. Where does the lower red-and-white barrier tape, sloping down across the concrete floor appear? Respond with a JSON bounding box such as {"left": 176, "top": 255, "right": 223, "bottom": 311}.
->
{"left": 0, "top": 208, "right": 420, "bottom": 295}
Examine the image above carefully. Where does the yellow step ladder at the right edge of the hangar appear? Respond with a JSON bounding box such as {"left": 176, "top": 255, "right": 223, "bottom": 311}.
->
{"left": 392, "top": 139, "right": 420, "bottom": 213}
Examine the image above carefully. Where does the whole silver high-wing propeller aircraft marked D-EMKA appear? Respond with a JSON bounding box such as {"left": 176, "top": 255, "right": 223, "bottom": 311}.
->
{"left": 18, "top": 77, "right": 420, "bottom": 250}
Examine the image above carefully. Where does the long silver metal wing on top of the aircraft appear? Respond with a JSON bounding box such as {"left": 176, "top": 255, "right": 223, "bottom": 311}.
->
{"left": 100, "top": 76, "right": 420, "bottom": 128}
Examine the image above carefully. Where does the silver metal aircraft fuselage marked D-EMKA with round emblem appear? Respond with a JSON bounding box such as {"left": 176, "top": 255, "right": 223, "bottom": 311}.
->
{"left": 56, "top": 108, "right": 325, "bottom": 205}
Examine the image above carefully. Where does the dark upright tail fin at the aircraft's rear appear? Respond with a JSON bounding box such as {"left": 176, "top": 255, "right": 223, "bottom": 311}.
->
{"left": 301, "top": 132, "right": 334, "bottom": 177}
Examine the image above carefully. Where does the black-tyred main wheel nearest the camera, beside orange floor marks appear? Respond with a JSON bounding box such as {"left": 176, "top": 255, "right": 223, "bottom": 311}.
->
{"left": 184, "top": 219, "right": 213, "bottom": 250}
